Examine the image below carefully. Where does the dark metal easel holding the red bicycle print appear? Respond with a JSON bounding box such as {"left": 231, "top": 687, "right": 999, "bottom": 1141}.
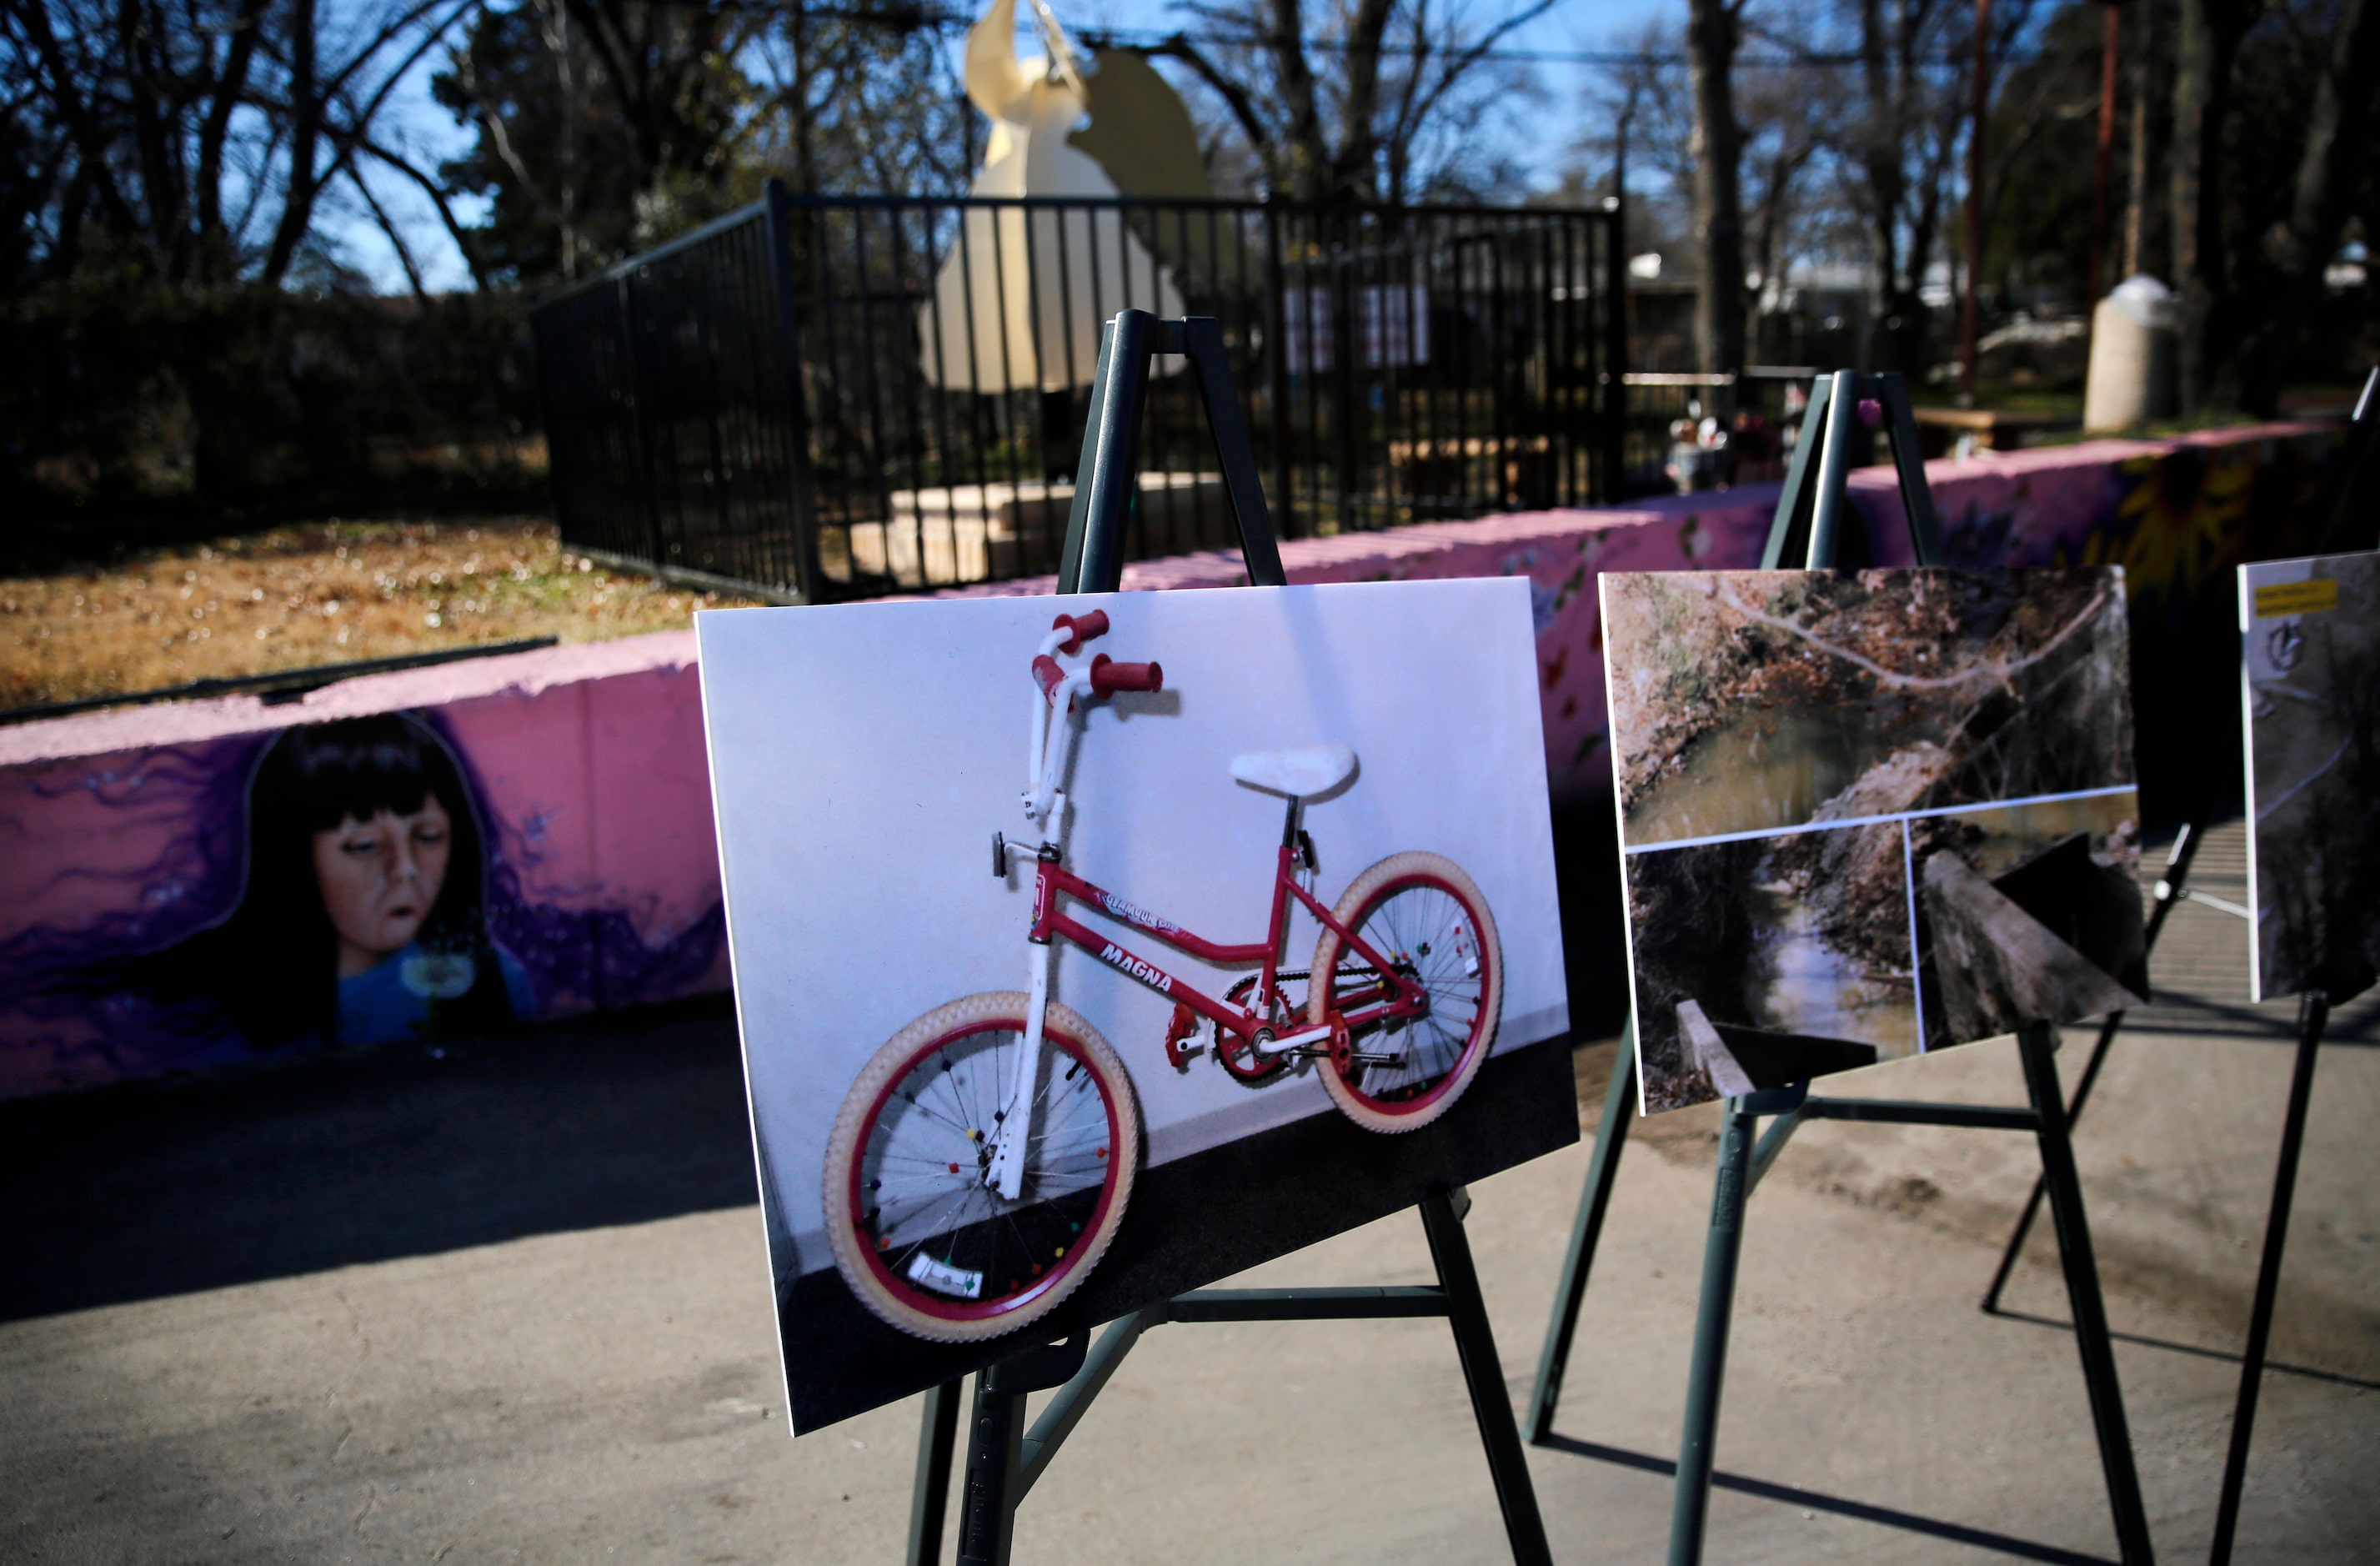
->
{"left": 907, "top": 309, "right": 1551, "bottom": 1566}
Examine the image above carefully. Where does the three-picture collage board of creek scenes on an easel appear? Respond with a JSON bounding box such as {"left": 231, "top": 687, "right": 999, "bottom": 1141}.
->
{"left": 1601, "top": 569, "right": 2147, "bottom": 1114}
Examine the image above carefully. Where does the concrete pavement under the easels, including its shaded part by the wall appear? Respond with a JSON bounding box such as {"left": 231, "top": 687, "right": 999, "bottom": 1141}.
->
{"left": 0, "top": 833, "right": 2380, "bottom": 1563}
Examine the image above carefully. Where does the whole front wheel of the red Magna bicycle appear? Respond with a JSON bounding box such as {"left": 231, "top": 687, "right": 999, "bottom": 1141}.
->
{"left": 824, "top": 990, "right": 1140, "bottom": 1343}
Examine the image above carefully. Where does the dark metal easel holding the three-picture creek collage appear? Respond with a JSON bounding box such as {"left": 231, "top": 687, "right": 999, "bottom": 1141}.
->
{"left": 1528, "top": 371, "right": 2154, "bottom": 1566}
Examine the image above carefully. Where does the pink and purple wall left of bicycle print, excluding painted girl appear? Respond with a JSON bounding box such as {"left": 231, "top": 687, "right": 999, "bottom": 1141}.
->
{"left": 0, "top": 630, "right": 726, "bottom": 1097}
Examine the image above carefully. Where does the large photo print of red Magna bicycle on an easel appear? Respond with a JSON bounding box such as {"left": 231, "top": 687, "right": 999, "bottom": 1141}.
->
{"left": 699, "top": 580, "right": 1576, "bottom": 1433}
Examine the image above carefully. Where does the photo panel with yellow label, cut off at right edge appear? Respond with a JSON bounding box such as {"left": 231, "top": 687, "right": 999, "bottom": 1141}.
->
{"left": 2240, "top": 552, "right": 2380, "bottom": 1004}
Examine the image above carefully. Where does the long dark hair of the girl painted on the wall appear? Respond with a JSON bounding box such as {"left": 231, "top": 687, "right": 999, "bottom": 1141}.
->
{"left": 126, "top": 714, "right": 512, "bottom": 1050}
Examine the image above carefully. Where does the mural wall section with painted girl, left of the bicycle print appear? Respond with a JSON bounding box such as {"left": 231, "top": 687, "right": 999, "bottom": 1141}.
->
{"left": 0, "top": 633, "right": 726, "bottom": 1097}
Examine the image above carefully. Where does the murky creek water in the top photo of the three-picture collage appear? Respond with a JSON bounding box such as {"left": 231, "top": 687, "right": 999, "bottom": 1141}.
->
{"left": 1628, "top": 702, "right": 1892, "bottom": 842}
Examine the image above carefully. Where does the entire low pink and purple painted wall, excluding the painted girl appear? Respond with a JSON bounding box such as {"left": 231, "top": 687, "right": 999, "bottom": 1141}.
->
{"left": 0, "top": 426, "right": 2332, "bottom": 1097}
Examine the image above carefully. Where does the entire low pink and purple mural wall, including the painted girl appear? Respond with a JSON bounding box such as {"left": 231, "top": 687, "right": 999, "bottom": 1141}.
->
{"left": 0, "top": 426, "right": 2335, "bottom": 1097}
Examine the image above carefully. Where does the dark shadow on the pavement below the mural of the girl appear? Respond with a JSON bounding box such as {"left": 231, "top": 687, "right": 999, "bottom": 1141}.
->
{"left": 0, "top": 995, "right": 757, "bottom": 1321}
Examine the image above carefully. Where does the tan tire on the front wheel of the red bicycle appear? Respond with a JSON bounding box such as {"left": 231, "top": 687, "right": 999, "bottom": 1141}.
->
{"left": 821, "top": 990, "right": 1140, "bottom": 1343}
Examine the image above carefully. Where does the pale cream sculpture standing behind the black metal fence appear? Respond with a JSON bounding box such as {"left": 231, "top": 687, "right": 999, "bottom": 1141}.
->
{"left": 919, "top": 0, "right": 1183, "bottom": 393}
